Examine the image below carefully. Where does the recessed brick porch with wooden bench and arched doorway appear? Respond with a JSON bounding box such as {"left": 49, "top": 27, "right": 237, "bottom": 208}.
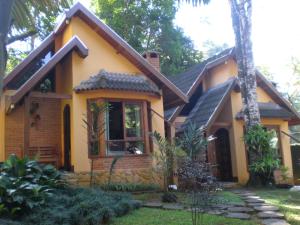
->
{"left": 5, "top": 91, "right": 72, "bottom": 170}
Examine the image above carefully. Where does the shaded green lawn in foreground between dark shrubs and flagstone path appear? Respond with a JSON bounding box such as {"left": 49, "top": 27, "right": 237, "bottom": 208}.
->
{"left": 112, "top": 208, "right": 256, "bottom": 225}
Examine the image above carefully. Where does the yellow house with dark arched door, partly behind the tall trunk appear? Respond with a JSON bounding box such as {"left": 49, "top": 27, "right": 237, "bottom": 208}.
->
{"left": 165, "top": 48, "right": 300, "bottom": 184}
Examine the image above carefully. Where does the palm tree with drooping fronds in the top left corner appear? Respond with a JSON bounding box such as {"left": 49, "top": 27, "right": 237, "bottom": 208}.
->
{"left": 0, "top": 0, "right": 71, "bottom": 95}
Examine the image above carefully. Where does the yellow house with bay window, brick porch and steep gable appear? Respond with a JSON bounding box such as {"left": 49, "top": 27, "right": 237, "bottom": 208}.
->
{"left": 0, "top": 3, "right": 187, "bottom": 185}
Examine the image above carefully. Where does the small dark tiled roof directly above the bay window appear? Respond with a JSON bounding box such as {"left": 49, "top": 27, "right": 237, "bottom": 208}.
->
{"left": 74, "top": 70, "right": 161, "bottom": 96}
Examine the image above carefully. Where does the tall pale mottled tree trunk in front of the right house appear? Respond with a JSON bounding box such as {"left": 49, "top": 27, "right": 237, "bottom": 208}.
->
{"left": 229, "top": 0, "right": 260, "bottom": 185}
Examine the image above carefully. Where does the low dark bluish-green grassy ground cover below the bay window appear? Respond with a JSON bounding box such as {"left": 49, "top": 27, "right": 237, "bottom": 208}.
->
{"left": 22, "top": 188, "right": 140, "bottom": 225}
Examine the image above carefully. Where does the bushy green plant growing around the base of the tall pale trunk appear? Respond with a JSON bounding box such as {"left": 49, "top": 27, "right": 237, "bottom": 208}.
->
{"left": 244, "top": 125, "right": 280, "bottom": 185}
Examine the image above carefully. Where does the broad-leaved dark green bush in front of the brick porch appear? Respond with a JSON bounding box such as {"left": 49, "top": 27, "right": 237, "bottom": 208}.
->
{"left": 0, "top": 155, "right": 64, "bottom": 216}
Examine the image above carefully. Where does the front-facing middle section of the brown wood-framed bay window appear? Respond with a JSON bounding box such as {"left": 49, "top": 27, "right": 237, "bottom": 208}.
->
{"left": 106, "top": 101, "right": 145, "bottom": 155}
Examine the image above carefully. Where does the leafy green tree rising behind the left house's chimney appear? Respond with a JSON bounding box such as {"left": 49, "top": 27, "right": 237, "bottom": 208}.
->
{"left": 92, "top": 0, "right": 202, "bottom": 75}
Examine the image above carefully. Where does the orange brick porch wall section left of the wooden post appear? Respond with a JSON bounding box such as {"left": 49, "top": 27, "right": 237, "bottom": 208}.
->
{"left": 5, "top": 104, "right": 25, "bottom": 158}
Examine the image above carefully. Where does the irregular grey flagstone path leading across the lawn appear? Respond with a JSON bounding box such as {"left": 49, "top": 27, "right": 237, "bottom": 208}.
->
{"left": 143, "top": 190, "right": 289, "bottom": 225}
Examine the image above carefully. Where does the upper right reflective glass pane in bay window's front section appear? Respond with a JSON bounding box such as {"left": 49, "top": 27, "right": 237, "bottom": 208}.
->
{"left": 125, "top": 104, "right": 142, "bottom": 137}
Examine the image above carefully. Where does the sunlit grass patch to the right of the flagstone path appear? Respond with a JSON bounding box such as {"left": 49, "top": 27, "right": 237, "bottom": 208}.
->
{"left": 254, "top": 189, "right": 300, "bottom": 225}
